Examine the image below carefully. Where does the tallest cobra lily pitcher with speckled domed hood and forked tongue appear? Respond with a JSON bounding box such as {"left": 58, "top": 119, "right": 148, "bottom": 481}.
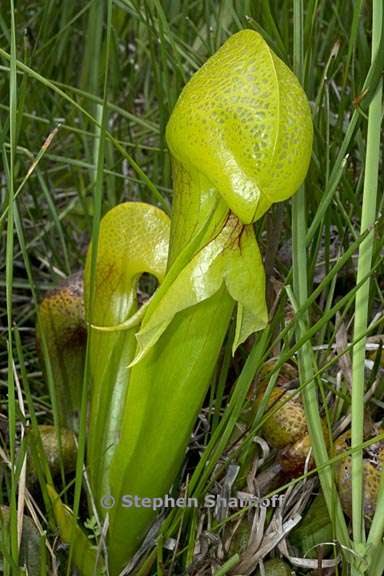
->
{"left": 104, "top": 30, "right": 312, "bottom": 576}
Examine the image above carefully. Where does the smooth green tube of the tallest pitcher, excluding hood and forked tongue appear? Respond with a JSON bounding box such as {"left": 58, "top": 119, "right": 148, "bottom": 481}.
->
{"left": 108, "top": 173, "right": 235, "bottom": 574}
